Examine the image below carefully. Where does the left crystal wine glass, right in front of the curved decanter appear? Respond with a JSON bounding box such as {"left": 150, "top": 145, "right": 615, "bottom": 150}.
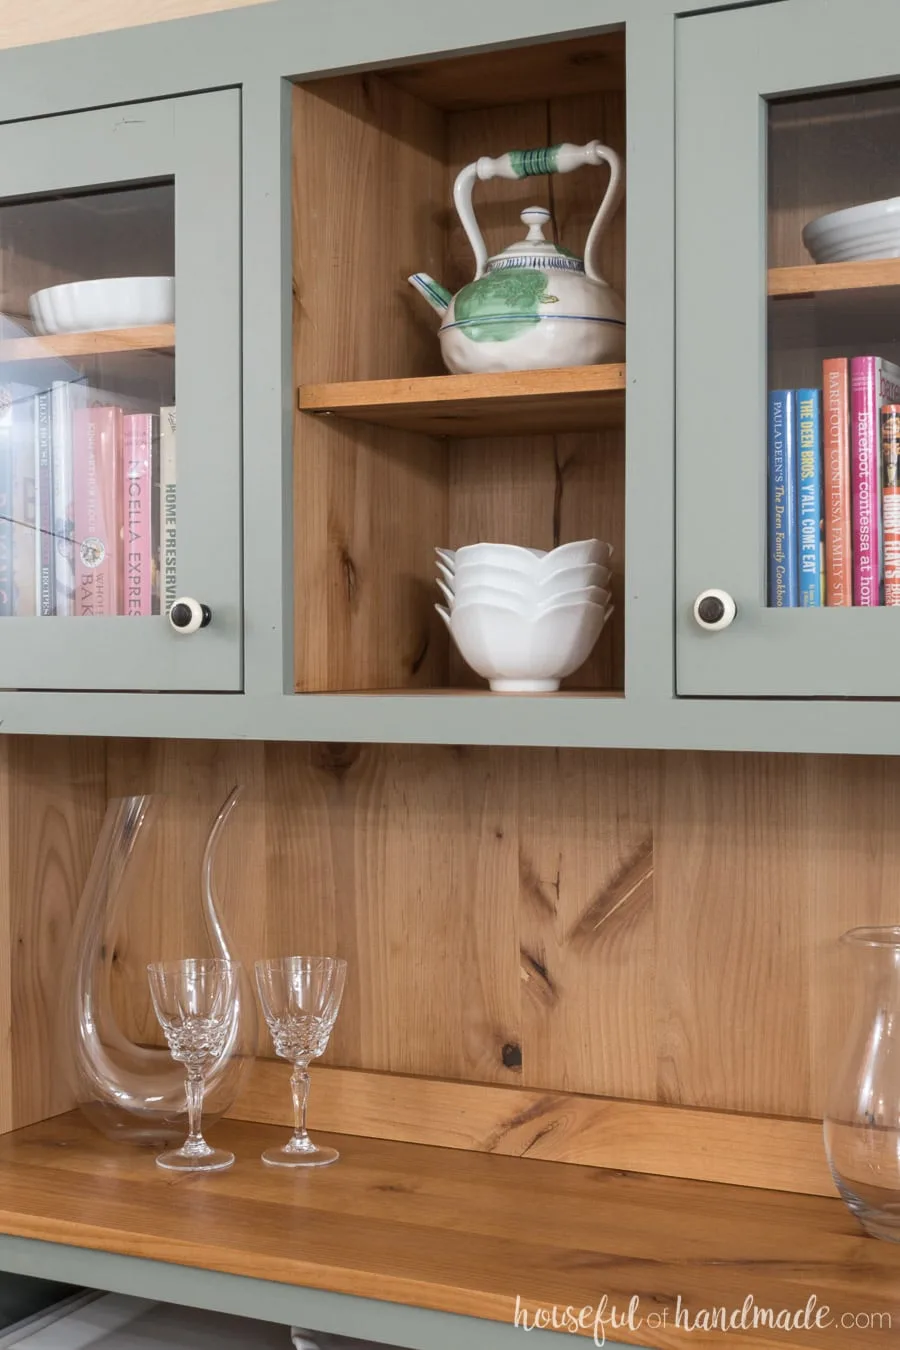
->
{"left": 147, "top": 957, "right": 240, "bottom": 1172}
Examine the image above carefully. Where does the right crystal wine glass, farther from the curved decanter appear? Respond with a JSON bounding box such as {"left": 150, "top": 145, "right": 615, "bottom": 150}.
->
{"left": 256, "top": 956, "right": 347, "bottom": 1168}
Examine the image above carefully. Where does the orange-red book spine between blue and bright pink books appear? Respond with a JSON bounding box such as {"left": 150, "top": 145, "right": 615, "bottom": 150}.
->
{"left": 822, "top": 356, "right": 853, "bottom": 605}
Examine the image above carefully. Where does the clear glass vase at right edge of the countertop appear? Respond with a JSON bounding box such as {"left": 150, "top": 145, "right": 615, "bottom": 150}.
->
{"left": 824, "top": 927, "right": 900, "bottom": 1242}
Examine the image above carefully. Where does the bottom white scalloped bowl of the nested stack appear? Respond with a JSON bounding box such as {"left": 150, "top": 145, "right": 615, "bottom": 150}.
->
{"left": 434, "top": 602, "right": 613, "bottom": 694}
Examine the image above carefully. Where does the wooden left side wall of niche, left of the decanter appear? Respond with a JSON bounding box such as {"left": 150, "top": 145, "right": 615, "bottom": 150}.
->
{"left": 0, "top": 736, "right": 105, "bottom": 1133}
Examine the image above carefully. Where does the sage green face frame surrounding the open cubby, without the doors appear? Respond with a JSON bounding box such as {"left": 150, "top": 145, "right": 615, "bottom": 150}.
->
{"left": 15, "top": 0, "right": 900, "bottom": 753}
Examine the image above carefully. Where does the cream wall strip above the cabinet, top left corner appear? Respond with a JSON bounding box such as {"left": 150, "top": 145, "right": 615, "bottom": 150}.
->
{"left": 0, "top": 0, "right": 275, "bottom": 47}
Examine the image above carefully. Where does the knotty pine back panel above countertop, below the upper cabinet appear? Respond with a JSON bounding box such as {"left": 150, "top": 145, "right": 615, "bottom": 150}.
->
{"left": 97, "top": 741, "right": 900, "bottom": 1118}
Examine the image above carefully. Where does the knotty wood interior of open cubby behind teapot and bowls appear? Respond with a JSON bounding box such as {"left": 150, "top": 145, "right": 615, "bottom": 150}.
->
{"left": 293, "top": 30, "right": 625, "bottom": 694}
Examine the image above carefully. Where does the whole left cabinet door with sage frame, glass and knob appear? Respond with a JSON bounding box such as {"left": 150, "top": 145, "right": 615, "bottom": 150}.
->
{"left": 0, "top": 90, "right": 242, "bottom": 690}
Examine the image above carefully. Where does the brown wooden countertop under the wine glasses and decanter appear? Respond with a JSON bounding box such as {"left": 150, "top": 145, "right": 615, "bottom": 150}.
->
{"left": 0, "top": 1112, "right": 900, "bottom": 1350}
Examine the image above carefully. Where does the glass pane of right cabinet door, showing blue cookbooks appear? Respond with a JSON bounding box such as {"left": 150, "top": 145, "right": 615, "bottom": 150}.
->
{"left": 766, "top": 85, "right": 900, "bottom": 609}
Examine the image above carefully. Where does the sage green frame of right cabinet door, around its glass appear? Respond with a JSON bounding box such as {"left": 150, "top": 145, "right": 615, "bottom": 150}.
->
{"left": 676, "top": 0, "right": 900, "bottom": 696}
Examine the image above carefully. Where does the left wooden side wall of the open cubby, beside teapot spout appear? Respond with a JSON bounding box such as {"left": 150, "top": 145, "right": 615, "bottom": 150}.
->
{"left": 293, "top": 76, "right": 447, "bottom": 691}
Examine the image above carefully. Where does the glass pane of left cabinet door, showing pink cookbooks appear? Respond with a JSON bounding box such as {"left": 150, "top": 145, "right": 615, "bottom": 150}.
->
{"left": 0, "top": 181, "right": 175, "bottom": 618}
